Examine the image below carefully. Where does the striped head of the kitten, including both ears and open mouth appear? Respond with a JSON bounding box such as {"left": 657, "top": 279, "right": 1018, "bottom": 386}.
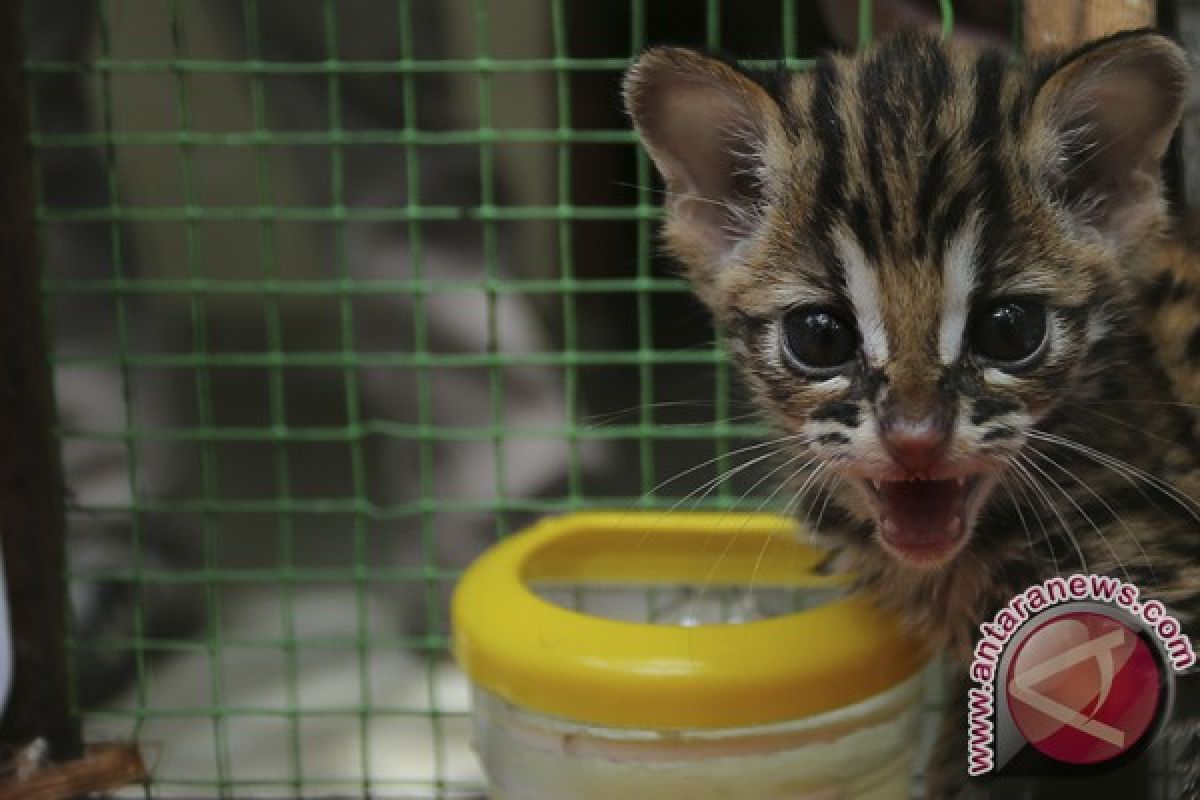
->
{"left": 625, "top": 31, "right": 1187, "bottom": 567}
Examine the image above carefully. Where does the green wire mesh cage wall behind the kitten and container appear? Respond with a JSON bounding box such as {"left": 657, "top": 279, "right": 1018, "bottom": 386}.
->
{"left": 7, "top": 0, "right": 1190, "bottom": 798}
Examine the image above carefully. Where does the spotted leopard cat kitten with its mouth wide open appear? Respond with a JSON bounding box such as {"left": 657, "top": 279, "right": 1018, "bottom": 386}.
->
{"left": 625, "top": 31, "right": 1200, "bottom": 796}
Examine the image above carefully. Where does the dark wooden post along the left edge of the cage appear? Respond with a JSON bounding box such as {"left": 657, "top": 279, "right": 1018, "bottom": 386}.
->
{"left": 0, "top": 2, "right": 80, "bottom": 760}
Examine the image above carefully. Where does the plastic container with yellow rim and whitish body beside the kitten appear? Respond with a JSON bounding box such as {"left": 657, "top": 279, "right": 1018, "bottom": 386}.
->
{"left": 454, "top": 512, "right": 928, "bottom": 800}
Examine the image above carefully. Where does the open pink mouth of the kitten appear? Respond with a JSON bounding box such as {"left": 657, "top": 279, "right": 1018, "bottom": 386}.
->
{"left": 866, "top": 475, "right": 979, "bottom": 566}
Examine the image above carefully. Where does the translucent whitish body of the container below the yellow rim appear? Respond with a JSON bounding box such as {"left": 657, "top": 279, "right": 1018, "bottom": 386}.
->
{"left": 473, "top": 674, "right": 923, "bottom": 800}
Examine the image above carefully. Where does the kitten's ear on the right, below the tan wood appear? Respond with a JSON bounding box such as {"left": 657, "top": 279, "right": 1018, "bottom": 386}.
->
{"left": 1032, "top": 30, "right": 1188, "bottom": 246}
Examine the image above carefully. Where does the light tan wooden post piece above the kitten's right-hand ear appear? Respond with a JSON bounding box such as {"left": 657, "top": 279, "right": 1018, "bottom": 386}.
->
{"left": 1022, "top": 0, "right": 1156, "bottom": 53}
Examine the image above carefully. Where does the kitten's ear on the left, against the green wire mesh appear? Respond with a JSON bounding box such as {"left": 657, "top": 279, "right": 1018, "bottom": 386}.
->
{"left": 625, "top": 47, "right": 782, "bottom": 287}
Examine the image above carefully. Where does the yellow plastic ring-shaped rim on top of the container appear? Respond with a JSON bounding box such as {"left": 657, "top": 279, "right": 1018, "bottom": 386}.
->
{"left": 454, "top": 511, "right": 928, "bottom": 730}
